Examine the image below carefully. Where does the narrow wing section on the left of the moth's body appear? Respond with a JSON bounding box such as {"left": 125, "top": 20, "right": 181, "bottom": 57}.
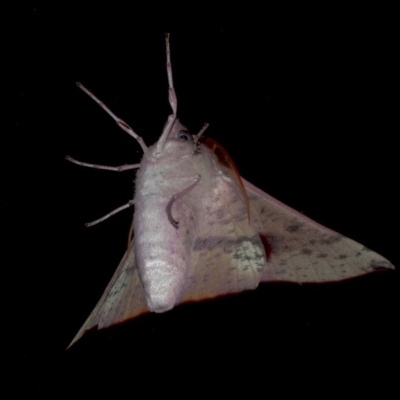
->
{"left": 68, "top": 243, "right": 149, "bottom": 347}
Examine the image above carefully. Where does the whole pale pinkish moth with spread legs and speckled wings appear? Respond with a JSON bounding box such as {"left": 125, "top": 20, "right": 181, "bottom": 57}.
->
{"left": 67, "top": 34, "right": 394, "bottom": 346}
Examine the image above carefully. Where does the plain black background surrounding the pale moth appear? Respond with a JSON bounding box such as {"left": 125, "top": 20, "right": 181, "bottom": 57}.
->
{"left": 2, "top": 2, "right": 400, "bottom": 397}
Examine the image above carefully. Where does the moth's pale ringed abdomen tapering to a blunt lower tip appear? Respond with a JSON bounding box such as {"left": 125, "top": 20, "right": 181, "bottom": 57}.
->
{"left": 134, "top": 189, "right": 197, "bottom": 312}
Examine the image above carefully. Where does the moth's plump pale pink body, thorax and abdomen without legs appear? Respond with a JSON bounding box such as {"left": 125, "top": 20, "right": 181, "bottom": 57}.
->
{"left": 134, "top": 139, "right": 220, "bottom": 312}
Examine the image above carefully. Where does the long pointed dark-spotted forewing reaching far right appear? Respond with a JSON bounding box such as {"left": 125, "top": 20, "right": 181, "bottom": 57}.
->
{"left": 243, "top": 180, "right": 394, "bottom": 283}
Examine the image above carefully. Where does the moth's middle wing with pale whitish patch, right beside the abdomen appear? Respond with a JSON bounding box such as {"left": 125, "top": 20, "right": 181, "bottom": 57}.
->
{"left": 181, "top": 177, "right": 265, "bottom": 302}
